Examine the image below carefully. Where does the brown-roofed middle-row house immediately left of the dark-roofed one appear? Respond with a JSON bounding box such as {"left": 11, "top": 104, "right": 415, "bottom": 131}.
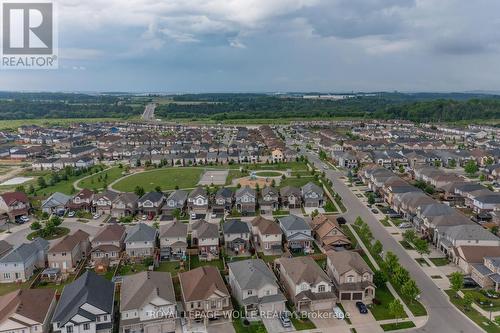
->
{"left": 191, "top": 220, "right": 219, "bottom": 261}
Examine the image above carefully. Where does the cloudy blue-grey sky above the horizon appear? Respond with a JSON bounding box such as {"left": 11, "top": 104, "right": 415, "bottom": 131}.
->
{"left": 0, "top": 0, "right": 500, "bottom": 92}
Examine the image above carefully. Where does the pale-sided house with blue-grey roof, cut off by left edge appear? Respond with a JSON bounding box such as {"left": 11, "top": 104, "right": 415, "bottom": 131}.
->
{"left": 0, "top": 238, "right": 49, "bottom": 283}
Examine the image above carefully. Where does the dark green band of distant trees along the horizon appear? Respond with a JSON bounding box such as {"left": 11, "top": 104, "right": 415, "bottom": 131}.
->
{"left": 0, "top": 92, "right": 500, "bottom": 122}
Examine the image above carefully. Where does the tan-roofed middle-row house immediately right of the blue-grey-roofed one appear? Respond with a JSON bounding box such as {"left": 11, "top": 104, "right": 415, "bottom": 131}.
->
{"left": 160, "top": 220, "right": 188, "bottom": 260}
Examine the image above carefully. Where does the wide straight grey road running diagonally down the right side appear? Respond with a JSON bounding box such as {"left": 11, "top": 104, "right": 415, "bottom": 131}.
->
{"left": 303, "top": 152, "right": 481, "bottom": 333}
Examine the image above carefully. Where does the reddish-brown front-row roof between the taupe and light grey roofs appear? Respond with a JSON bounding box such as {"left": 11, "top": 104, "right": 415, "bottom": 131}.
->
{"left": 179, "top": 266, "right": 229, "bottom": 302}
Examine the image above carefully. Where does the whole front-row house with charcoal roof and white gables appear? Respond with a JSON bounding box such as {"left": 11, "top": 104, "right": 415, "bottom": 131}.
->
{"left": 52, "top": 271, "right": 115, "bottom": 333}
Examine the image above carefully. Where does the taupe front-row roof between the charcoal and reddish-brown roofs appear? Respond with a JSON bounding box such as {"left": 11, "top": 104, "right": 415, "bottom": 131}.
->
{"left": 120, "top": 272, "right": 176, "bottom": 311}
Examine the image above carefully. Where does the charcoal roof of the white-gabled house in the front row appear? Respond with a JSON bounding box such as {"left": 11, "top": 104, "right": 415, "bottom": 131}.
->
{"left": 52, "top": 271, "right": 115, "bottom": 326}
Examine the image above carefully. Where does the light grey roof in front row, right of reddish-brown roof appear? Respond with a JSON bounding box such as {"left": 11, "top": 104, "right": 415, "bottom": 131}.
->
{"left": 227, "top": 259, "right": 277, "bottom": 289}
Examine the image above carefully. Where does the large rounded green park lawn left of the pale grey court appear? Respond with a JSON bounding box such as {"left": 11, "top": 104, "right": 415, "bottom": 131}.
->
{"left": 113, "top": 167, "right": 203, "bottom": 192}
